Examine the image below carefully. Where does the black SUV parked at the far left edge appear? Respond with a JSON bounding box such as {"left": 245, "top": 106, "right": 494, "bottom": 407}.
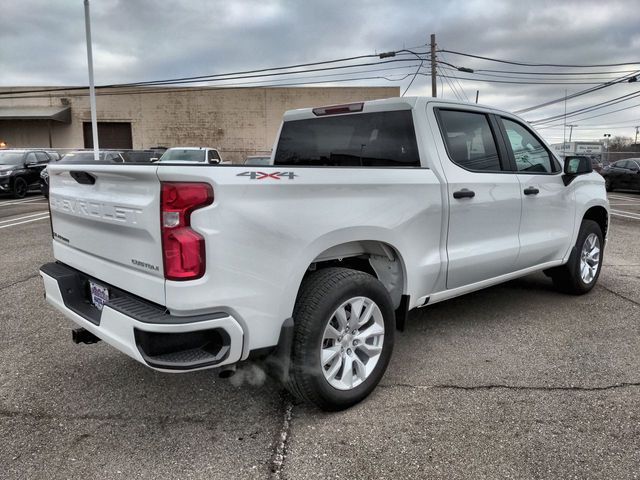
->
{"left": 0, "top": 149, "right": 52, "bottom": 198}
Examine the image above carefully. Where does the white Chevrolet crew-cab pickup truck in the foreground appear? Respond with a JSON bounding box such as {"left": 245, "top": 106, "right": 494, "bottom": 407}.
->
{"left": 40, "top": 98, "right": 609, "bottom": 410}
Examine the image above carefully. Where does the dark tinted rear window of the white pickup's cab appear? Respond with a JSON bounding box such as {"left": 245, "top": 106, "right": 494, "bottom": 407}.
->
{"left": 274, "top": 110, "right": 420, "bottom": 167}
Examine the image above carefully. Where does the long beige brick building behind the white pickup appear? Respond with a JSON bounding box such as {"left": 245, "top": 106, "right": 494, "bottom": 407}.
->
{"left": 0, "top": 87, "right": 400, "bottom": 161}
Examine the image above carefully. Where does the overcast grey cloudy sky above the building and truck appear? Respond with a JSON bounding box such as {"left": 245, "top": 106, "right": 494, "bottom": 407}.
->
{"left": 0, "top": 0, "right": 640, "bottom": 143}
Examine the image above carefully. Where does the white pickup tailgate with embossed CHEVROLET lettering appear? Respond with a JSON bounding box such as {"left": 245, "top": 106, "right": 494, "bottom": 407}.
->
{"left": 48, "top": 164, "right": 165, "bottom": 305}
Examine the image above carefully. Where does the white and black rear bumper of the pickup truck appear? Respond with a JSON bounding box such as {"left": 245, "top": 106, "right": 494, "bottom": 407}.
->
{"left": 40, "top": 263, "right": 244, "bottom": 372}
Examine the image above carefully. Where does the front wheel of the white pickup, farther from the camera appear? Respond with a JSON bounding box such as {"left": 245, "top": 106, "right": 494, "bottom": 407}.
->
{"left": 547, "top": 220, "right": 604, "bottom": 295}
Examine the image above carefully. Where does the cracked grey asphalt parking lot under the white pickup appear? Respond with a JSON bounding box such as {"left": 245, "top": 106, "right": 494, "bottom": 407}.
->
{"left": 0, "top": 192, "right": 640, "bottom": 479}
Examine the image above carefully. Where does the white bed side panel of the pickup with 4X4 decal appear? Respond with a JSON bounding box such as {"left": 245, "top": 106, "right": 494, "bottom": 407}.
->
{"left": 158, "top": 166, "right": 444, "bottom": 353}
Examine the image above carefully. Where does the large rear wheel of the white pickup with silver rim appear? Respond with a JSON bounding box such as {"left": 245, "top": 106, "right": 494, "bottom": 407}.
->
{"left": 286, "top": 268, "right": 395, "bottom": 411}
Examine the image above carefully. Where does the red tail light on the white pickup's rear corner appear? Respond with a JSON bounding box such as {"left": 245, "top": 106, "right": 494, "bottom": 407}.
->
{"left": 160, "top": 182, "right": 213, "bottom": 280}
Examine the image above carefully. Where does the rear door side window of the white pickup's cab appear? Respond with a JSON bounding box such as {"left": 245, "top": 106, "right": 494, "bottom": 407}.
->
{"left": 438, "top": 109, "right": 502, "bottom": 172}
